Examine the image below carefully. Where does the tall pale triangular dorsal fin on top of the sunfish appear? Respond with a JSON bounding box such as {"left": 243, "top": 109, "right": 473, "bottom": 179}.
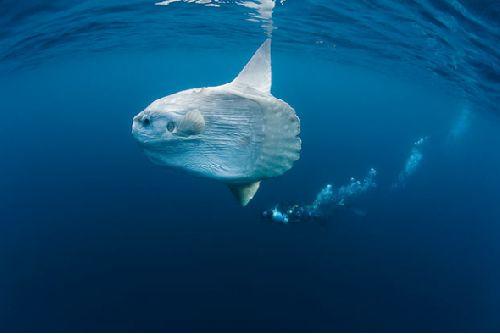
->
{"left": 232, "top": 38, "right": 272, "bottom": 94}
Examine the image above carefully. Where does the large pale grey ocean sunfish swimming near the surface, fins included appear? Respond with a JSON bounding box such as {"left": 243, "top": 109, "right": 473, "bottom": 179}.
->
{"left": 132, "top": 39, "right": 301, "bottom": 205}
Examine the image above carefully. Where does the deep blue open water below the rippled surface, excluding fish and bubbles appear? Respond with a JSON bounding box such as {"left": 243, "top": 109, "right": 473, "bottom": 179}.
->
{"left": 0, "top": 1, "right": 500, "bottom": 331}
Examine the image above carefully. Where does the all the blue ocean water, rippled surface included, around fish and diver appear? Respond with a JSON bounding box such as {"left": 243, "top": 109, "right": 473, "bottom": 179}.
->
{"left": 0, "top": 0, "right": 500, "bottom": 331}
